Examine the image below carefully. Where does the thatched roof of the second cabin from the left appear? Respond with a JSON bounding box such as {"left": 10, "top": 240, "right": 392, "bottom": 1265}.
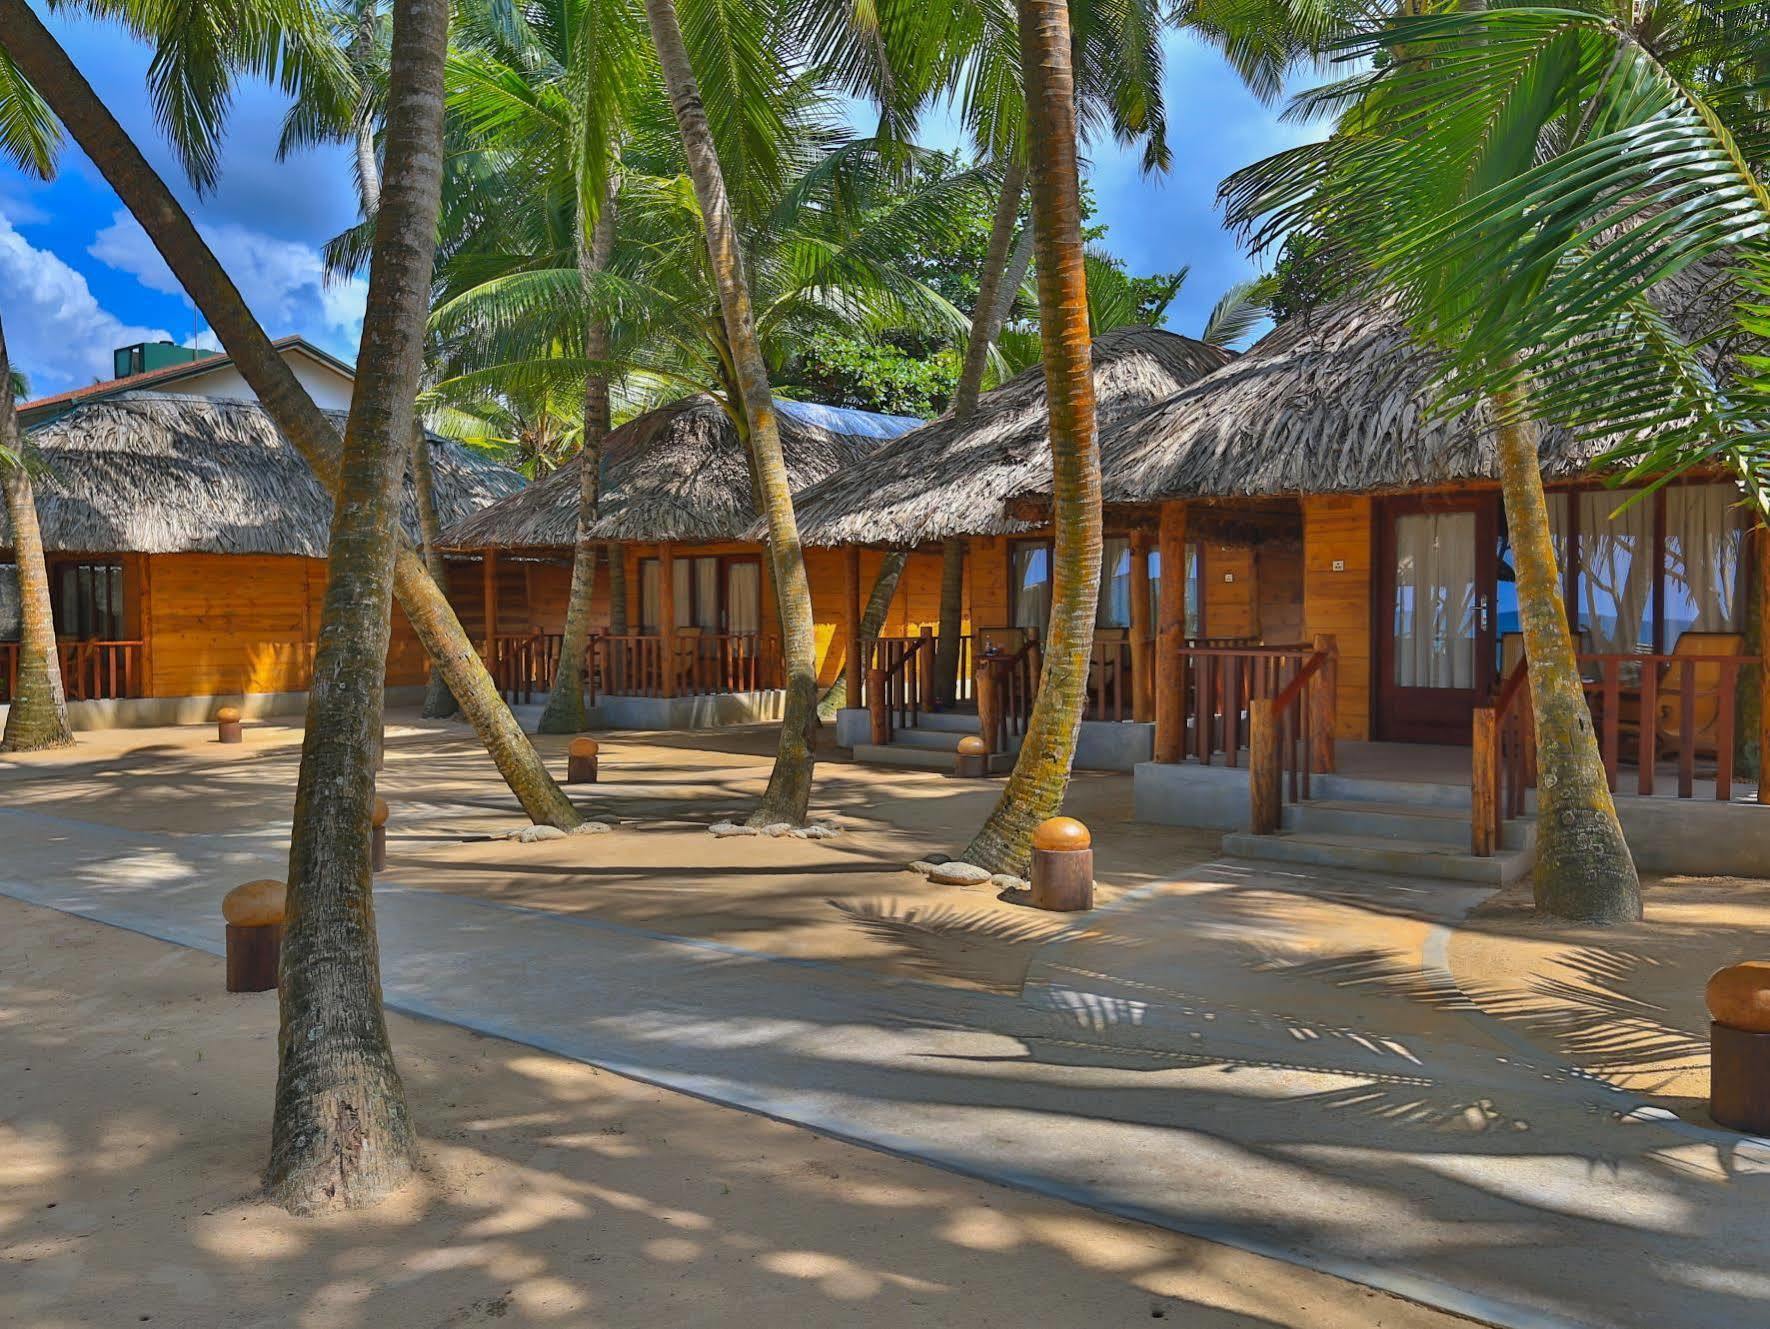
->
{"left": 443, "top": 393, "right": 915, "bottom": 549}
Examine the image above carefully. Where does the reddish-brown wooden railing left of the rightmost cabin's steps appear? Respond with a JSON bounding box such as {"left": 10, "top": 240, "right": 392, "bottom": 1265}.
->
{"left": 1179, "top": 639, "right": 1336, "bottom": 770}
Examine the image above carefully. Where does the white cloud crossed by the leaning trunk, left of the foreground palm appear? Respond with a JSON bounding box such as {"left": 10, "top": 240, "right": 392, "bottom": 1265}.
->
{"left": 87, "top": 212, "right": 368, "bottom": 359}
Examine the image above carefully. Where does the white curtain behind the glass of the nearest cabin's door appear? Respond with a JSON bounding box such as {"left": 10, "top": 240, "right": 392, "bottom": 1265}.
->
{"left": 1395, "top": 511, "right": 1474, "bottom": 688}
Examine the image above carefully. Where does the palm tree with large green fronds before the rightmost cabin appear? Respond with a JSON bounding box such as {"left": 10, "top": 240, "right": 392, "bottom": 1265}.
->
{"left": 1227, "top": 5, "right": 1770, "bottom": 922}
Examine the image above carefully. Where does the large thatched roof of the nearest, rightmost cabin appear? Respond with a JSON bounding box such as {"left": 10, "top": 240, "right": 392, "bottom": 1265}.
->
{"left": 1097, "top": 269, "right": 1751, "bottom": 503}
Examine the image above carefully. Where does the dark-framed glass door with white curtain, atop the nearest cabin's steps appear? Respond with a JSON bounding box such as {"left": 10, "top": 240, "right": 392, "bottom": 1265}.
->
{"left": 1375, "top": 494, "right": 1499, "bottom": 743}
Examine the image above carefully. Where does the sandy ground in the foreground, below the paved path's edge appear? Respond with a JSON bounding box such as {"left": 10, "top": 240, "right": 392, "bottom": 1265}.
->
{"left": 0, "top": 899, "right": 1464, "bottom": 1329}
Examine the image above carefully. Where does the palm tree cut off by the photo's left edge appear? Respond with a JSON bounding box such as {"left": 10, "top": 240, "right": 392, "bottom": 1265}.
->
{"left": 0, "top": 53, "right": 74, "bottom": 752}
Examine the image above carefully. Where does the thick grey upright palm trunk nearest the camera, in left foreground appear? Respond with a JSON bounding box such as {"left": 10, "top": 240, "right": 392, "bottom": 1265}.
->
{"left": 266, "top": 0, "right": 448, "bottom": 1212}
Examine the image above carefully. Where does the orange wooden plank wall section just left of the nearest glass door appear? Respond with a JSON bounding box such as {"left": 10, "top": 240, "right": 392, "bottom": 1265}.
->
{"left": 1303, "top": 497, "right": 1374, "bottom": 738}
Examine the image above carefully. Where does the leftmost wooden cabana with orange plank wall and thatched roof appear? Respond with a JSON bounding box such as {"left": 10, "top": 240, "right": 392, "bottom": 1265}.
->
{"left": 0, "top": 391, "right": 522, "bottom": 727}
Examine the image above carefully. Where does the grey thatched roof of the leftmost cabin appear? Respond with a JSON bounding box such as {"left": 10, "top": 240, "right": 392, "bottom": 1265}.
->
{"left": 0, "top": 393, "right": 522, "bottom": 557}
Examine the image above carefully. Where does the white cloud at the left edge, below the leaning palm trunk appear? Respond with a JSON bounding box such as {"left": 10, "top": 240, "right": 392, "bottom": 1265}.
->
{"left": 0, "top": 214, "right": 170, "bottom": 396}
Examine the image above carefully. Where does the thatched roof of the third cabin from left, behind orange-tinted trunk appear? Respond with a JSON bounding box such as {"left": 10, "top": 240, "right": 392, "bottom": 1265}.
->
{"left": 795, "top": 327, "right": 1230, "bottom": 545}
